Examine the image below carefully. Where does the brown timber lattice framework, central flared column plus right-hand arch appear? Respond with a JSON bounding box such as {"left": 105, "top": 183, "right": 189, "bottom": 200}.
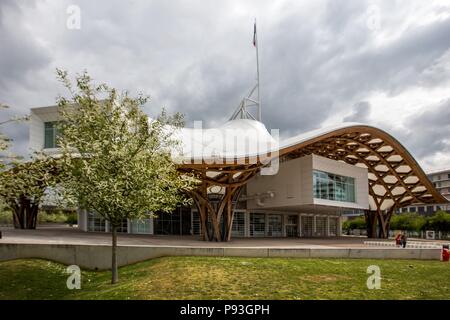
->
{"left": 179, "top": 125, "right": 447, "bottom": 241}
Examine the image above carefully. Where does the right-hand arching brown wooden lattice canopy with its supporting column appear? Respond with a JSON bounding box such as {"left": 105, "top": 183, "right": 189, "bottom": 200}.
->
{"left": 280, "top": 125, "right": 447, "bottom": 237}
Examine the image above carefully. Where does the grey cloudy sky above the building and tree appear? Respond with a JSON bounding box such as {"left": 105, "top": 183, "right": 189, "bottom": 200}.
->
{"left": 0, "top": 0, "right": 450, "bottom": 170}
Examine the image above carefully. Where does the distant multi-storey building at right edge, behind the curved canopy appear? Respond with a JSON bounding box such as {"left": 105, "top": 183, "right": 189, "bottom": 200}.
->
{"left": 397, "top": 169, "right": 450, "bottom": 215}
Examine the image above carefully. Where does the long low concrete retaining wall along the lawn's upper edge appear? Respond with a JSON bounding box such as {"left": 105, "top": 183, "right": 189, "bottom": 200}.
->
{"left": 0, "top": 243, "right": 440, "bottom": 270}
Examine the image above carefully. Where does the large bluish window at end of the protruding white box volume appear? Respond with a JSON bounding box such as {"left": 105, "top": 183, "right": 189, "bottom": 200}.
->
{"left": 313, "top": 170, "right": 356, "bottom": 202}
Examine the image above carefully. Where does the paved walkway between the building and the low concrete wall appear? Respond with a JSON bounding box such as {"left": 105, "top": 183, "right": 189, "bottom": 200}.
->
{"left": 0, "top": 226, "right": 446, "bottom": 248}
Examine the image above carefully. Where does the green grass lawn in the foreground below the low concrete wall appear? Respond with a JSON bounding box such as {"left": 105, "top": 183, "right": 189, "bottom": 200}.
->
{"left": 0, "top": 257, "right": 450, "bottom": 299}
